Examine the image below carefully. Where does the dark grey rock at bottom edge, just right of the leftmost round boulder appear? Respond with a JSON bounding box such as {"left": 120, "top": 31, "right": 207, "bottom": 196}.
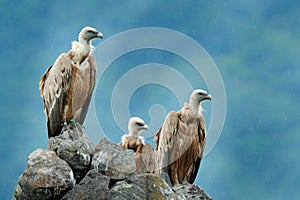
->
{"left": 62, "top": 170, "right": 110, "bottom": 200}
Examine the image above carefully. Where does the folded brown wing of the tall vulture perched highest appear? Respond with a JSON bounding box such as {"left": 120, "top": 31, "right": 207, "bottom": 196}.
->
{"left": 39, "top": 53, "right": 72, "bottom": 138}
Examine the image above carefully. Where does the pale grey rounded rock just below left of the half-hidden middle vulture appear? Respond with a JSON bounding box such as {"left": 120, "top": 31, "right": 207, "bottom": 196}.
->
{"left": 92, "top": 138, "right": 136, "bottom": 179}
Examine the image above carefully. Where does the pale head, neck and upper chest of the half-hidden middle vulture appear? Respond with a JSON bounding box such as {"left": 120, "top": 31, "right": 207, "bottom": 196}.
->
{"left": 119, "top": 117, "right": 148, "bottom": 152}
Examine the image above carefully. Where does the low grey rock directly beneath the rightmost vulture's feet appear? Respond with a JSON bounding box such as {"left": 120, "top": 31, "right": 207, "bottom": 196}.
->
{"left": 173, "top": 183, "right": 212, "bottom": 200}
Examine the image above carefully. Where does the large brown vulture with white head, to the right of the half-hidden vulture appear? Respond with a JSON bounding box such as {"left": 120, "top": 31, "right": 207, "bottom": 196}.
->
{"left": 155, "top": 89, "right": 211, "bottom": 185}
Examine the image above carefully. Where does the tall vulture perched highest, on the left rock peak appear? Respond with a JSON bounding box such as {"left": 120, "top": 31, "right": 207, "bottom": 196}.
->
{"left": 39, "top": 27, "right": 103, "bottom": 138}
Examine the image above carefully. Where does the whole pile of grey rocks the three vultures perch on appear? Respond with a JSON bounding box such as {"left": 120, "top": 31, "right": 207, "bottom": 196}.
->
{"left": 14, "top": 124, "right": 211, "bottom": 200}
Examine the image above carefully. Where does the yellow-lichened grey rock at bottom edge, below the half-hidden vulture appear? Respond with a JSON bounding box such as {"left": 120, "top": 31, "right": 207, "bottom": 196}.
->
{"left": 111, "top": 174, "right": 176, "bottom": 200}
